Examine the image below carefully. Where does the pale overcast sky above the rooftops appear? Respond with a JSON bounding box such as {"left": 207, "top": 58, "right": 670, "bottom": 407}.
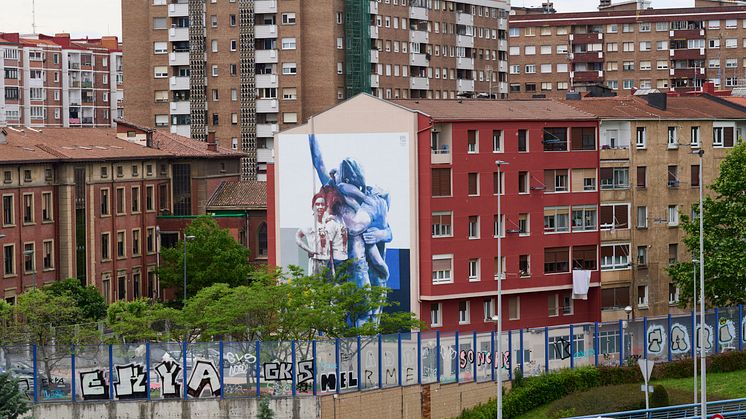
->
{"left": 0, "top": 0, "right": 694, "bottom": 37}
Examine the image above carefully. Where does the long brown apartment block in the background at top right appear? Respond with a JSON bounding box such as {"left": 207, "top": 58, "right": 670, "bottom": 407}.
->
{"left": 508, "top": 1, "right": 746, "bottom": 98}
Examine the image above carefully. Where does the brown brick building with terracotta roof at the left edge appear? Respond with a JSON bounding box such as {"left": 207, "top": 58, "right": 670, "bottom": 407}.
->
{"left": 0, "top": 127, "right": 241, "bottom": 302}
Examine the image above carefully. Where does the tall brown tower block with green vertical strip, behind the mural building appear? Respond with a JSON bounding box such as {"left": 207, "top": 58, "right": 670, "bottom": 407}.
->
{"left": 122, "top": 0, "right": 509, "bottom": 180}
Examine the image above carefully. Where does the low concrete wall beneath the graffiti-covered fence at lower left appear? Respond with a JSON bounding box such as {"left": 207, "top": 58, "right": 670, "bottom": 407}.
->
{"left": 27, "top": 397, "right": 320, "bottom": 419}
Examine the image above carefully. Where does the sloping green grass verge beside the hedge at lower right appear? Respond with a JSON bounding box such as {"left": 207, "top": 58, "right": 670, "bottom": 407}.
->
{"left": 518, "top": 371, "right": 746, "bottom": 419}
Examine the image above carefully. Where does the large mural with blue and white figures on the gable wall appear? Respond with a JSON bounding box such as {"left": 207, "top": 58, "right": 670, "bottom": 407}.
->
{"left": 277, "top": 133, "right": 411, "bottom": 325}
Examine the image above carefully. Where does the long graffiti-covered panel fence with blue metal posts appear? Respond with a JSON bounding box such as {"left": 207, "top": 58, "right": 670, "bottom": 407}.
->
{"left": 0, "top": 306, "right": 746, "bottom": 402}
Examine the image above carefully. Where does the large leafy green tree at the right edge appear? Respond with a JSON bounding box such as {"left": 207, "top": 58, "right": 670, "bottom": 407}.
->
{"left": 667, "top": 143, "right": 746, "bottom": 306}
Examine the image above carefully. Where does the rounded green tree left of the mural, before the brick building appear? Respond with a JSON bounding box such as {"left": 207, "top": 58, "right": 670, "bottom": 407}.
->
{"left": 159, "top": 216, "right": 252, "bottom": 306}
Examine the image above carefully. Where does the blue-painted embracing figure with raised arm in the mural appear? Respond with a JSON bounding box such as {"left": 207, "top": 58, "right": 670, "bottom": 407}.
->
{"left": 308, "top": 134, "right": 392, "bottom": 326}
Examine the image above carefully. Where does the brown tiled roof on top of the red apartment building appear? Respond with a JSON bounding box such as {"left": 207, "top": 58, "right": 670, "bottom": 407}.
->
{"left": 393, "top": 99, "right": 595, "bottom": 121}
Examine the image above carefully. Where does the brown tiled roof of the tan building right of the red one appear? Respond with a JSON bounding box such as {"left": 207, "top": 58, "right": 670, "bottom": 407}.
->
{"left": 562, "top": 96, "right": 746, "bottom": 119}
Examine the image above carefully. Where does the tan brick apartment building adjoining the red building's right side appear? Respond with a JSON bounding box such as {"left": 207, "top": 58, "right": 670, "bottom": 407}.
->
{"left": 564, "top": 92, "right": 746, "bottom": 321}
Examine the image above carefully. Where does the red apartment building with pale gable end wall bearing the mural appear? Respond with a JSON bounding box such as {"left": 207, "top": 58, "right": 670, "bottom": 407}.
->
{"left": 268, "top": 95, "right": 601, "bottom": 331}
